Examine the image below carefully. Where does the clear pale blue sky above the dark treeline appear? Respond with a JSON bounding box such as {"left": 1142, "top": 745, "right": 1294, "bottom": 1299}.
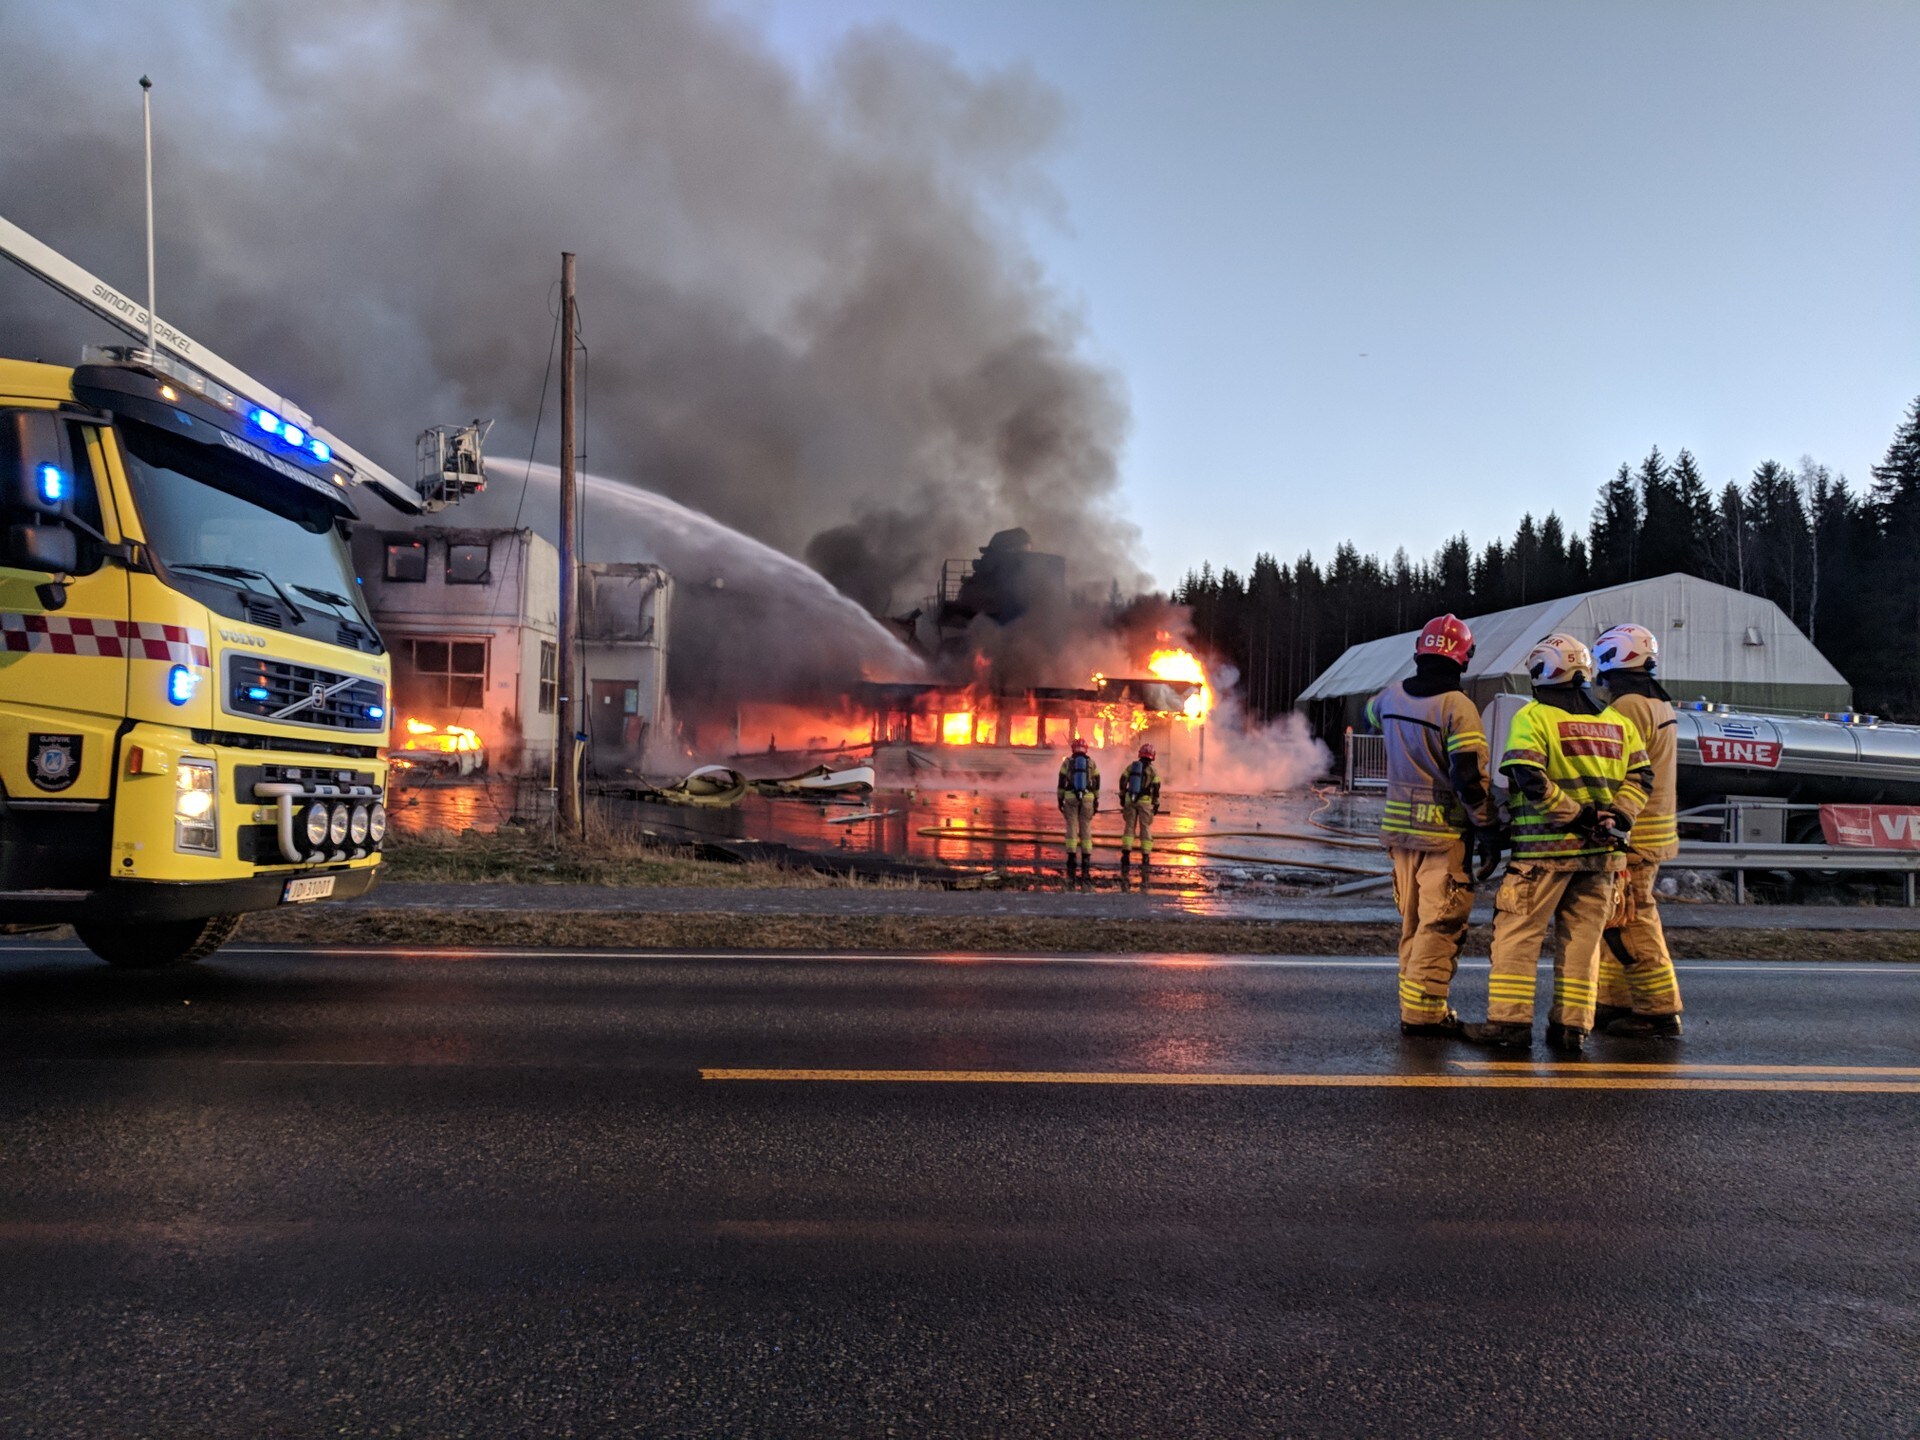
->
{"left": 733, "top": 0, "right": 1920, "bottom": 584}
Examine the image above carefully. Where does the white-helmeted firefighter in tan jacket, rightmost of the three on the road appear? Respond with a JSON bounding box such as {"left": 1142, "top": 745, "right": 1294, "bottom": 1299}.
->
{"left": 1594, "top": 624, "right": 1680, "bottom": 1037}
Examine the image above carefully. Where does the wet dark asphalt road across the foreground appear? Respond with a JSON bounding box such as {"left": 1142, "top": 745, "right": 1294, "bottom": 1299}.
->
{"left": 0, "top": 947, "right": 1920, "bottom": 1440}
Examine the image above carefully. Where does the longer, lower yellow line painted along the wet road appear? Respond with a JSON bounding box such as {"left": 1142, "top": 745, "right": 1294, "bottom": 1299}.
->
{"left": 701, "top": 1068, "right": 1920, "bottom": 1094}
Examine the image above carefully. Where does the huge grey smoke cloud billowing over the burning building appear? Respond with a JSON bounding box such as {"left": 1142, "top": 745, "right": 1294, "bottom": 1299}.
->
{"left": 0, "top": 0, "right": 1142, "bottom": 629}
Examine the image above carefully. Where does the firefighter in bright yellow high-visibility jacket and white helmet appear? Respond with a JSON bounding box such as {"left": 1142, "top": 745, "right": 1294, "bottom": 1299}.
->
{"left": 1465, "top": 636, "right": 1653, "bottom": 1050}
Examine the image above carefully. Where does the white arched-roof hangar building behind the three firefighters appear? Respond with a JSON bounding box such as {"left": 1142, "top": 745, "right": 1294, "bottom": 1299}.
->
{"left": 1300, "top": 574, "right": 1853, "bottom": 733}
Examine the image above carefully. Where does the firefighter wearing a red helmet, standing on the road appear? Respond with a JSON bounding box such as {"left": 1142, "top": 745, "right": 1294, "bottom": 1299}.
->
{"left": 1367, "top": 614, "right": 1501, "bottom": 1035}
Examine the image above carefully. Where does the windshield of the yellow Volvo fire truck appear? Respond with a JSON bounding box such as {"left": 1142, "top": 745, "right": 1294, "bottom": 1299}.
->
{"left": 117, "top": 420, "right": 372, "bottom": 639}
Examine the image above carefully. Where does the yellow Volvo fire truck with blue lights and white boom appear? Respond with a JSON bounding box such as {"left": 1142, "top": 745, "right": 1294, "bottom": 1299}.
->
{"left": 0, "top": 221, "right": 460, "bottom": 968}
